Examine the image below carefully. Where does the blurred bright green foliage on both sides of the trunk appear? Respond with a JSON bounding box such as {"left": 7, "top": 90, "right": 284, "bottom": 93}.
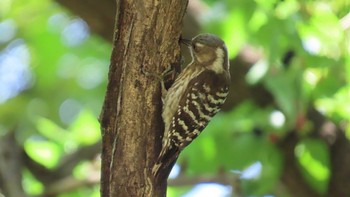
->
{"left": 0, "top": 0, "right": 350, "bottom": 196}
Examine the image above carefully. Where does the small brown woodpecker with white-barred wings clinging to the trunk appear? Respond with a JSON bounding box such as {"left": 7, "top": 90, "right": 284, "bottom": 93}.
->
{"left": 152, "top": 34, "right": 230, "bottom": 176}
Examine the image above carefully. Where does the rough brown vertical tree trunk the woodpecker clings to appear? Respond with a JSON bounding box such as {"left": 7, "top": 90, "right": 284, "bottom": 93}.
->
{"left": 100, "top": 0, "right": 188, "bottom": 197}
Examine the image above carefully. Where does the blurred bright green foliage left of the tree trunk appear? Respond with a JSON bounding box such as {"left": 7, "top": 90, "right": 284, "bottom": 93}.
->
{"left": 0, "top": 0, "right": 106, "bottom": 196}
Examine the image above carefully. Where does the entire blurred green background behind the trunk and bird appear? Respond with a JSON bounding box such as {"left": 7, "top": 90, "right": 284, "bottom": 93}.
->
{"left": 0, "top": 0, "right": 350, "bottom": 197}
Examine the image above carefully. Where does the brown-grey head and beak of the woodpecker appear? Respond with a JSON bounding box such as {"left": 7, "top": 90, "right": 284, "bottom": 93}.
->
{"left": 182, "top": 34, "right": 229, "bottom": 73}
